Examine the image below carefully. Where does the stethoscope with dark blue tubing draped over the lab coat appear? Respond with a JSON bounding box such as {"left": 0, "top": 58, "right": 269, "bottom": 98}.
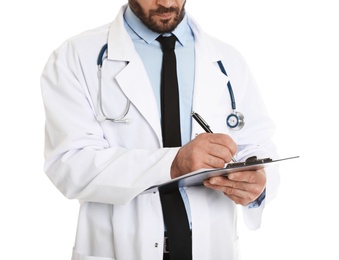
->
{"left": 97, "top": 43, "right": 245, "bottom": 130}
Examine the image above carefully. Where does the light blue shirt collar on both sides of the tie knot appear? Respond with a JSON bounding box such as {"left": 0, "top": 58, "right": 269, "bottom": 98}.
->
{"left": 124, "top": 6, "right": 192, "bottom": 46}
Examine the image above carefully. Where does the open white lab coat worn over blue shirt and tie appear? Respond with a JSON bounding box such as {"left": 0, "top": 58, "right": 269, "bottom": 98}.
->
{"left": 41, "top": 6, "right": 278, "bottom": 260}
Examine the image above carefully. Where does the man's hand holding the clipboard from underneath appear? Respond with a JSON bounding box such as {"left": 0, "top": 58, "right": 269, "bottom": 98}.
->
{"left": 204, "top": 169, "right": 266, "bottom": 206}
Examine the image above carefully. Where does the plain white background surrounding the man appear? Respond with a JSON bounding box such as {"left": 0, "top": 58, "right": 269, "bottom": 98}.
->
{"left": 0, "top": 0, "right": 339, "bottom": 260}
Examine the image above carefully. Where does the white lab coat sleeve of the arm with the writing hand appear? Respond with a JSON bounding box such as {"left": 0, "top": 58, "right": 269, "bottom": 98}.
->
{"left": 41, "top": 42, "right": 177, "bottom": 204}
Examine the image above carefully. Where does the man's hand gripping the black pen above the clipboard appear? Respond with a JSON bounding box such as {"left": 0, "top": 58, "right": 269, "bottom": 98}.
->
{"left": 171, "top": 133, "right": 237, "bottom": 179}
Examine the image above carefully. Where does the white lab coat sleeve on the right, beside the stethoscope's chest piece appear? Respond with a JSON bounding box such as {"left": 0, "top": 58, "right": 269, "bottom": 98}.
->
{"left": 219, "top": 44, "right": 280, "bottom": 230}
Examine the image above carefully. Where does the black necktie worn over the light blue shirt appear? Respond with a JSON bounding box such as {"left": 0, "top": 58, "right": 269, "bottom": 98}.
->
{"left": 157, "top": 35, "right": 192, "bottom": 260}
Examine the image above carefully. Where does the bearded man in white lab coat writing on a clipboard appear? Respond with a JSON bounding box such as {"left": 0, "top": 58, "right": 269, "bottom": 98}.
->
{"left": 41, "top": 0, "right": 278, "bottom": 260}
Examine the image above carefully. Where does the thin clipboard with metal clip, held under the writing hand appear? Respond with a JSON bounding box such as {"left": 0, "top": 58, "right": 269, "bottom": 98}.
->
{"left": 143, "top": 156, "right": 299, "bottom": 193}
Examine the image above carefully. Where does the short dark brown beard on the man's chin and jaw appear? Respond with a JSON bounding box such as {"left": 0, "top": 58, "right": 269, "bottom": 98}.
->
{"left": 128, "top": 0, "right": 186, "bottom": 33}
